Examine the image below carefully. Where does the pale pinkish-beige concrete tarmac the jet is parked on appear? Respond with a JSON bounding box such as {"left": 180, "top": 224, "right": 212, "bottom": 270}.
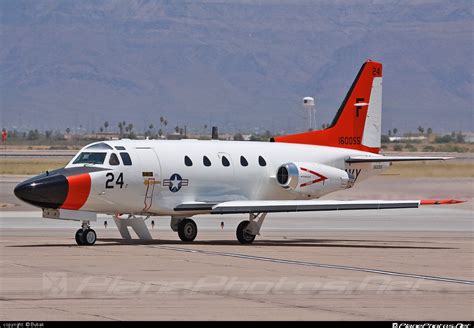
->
{"left": 0, "top": 177, "right": 474, "bottom": 321}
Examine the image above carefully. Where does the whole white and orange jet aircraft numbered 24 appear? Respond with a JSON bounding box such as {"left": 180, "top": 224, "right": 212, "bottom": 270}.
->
{"left": 14, "top": 60, "right": 458, "bottom": 245}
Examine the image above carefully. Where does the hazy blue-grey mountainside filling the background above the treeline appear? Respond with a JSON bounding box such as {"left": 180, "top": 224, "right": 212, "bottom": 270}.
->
{"left": 0, "top": 0, "right": 474, "bottom": 132}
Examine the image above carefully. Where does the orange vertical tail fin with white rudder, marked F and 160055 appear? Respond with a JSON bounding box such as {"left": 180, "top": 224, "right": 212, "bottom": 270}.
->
{"left": 271, "top": 60, "right": 382, "bottom": 154}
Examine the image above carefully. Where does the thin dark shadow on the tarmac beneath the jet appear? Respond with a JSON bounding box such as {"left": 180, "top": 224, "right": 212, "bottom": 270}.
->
{"left": 7, "top": 238, "right": 456, "bottom": 249}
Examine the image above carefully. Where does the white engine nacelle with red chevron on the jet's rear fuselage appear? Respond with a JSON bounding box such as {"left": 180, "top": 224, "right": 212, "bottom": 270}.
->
{"left": 276, "top": 162, "right": 355, "bottom": 197}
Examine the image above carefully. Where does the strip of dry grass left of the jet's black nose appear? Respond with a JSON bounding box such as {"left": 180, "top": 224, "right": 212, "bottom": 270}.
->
{"left": 0, "top": 158, "right": 69, "bottom": 175}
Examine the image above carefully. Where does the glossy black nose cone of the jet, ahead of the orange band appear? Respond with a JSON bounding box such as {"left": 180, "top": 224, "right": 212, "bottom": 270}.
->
{"left": 14, "top": 174, "right": 68, "bottom": 208}
